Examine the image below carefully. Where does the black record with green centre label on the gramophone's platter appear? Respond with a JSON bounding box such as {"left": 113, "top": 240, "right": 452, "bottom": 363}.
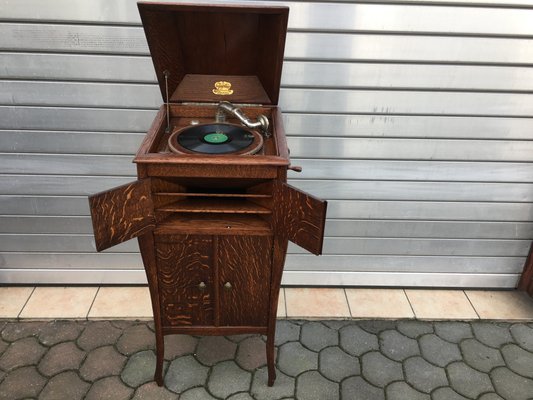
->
{"left": 168, "top": 123, "right": 263, "bottom": 155}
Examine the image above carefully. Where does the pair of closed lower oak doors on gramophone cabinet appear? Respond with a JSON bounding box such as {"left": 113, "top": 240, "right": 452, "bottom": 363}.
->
{"left": 155, "top": 234, "right": 273, "bottom": 328}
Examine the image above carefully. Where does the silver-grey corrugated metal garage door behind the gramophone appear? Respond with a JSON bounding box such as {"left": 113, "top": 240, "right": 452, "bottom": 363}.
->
{"left": 0, "top": 0, "right": 533, "bottom": 287}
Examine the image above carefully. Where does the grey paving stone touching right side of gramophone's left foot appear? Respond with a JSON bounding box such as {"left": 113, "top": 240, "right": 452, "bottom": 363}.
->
{"left": 165, "top": 356, "right": 209, "bottom": 393}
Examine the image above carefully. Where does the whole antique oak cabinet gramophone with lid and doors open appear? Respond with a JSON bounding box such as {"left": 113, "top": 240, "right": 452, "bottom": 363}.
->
{"left": 89, "top": 3, "right": 326, "bottom": 385}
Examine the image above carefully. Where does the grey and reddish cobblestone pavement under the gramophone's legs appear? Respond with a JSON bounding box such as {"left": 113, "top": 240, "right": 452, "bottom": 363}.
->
{"left": 0, "top": 320, "right": 533, "bottom": 400}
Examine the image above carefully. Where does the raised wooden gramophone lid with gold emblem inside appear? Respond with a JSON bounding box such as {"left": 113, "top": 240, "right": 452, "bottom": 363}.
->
{"left": 138, "top": 3, "right": 289, "bottom": 104}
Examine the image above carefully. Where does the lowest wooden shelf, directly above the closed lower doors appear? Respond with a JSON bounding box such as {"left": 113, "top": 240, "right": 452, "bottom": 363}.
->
{"left": 154, "top": 213, "right": 272, "bottom": 235}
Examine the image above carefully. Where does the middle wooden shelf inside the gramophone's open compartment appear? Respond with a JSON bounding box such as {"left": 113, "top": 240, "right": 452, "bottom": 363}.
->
{"left": 156, "top": 197, "right": 272, "bottom": 214}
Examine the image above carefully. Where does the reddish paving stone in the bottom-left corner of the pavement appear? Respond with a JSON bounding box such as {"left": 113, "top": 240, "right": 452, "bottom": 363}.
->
{"left": 0, "top": 366, "right": 46, "bottom": 400}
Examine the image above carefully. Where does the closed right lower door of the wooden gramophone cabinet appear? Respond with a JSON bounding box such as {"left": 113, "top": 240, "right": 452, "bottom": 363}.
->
{"left": 217, "top": 236, "right": 272, "bottom": 326}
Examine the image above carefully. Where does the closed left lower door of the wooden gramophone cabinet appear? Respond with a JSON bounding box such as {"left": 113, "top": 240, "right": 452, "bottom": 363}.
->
{"left": 156, "top": 235, "right": 214, "bottom": 326}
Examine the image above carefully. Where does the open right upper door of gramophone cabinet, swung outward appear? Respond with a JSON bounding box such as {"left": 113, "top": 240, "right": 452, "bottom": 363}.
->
{"left": 274, "top": 181, "right": 328, "bottom": 255}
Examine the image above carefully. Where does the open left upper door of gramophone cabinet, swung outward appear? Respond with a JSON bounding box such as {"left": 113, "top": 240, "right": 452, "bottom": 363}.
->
{"left": 89, "top": 178, "right": 155, "bottom": 251}
